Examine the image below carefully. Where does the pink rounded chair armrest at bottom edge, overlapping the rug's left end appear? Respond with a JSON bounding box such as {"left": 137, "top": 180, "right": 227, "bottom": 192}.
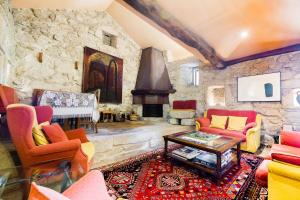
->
{"left": 63, "top": 170, "right": 112, "bottom": 200}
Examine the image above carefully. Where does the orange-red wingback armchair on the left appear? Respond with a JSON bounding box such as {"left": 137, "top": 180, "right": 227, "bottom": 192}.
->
{"left": 7, "top": 104, "right": 94, "bottom": 176}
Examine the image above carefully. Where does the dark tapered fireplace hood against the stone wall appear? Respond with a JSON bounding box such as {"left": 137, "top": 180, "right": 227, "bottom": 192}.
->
{"left": 131, "top": 47, "right": 176, "bottom": 104}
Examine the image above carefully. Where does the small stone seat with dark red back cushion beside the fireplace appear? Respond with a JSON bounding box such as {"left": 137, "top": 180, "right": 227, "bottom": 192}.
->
{"left": 168, "top": 100, "right": 197, "bottom": 126}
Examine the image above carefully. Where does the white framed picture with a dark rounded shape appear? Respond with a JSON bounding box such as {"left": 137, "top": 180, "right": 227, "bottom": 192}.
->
{"left": 237, "top": 72, "right": 281, "bottom": 102}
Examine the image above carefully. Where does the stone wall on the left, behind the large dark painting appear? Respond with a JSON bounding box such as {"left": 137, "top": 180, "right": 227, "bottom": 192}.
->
{"left": 11, "top": 9, "right": 140, "bottom": 110}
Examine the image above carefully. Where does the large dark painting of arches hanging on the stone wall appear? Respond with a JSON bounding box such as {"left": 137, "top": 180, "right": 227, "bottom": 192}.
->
{"left": 82, "top": 47, "right": 123, "bottom": 103}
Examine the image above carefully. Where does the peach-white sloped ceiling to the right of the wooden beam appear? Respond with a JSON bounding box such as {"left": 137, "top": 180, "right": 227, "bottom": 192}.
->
{"left": 156, "top": 0, "right": 300, "bottom": 60}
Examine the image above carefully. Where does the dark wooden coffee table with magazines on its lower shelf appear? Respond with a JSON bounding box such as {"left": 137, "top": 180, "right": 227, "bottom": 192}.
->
{"left": 164, "top": 131, "right": 242, "bottom": 179}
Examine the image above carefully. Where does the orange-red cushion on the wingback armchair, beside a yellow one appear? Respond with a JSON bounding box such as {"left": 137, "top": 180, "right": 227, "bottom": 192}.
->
{"left": 43, "top": 123, "right": 68, "bottom": 143}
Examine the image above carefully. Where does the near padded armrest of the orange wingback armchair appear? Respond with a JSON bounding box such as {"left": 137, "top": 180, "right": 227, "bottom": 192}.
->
{"left": 30, "top": 139, "right": 81, "bottom": 156}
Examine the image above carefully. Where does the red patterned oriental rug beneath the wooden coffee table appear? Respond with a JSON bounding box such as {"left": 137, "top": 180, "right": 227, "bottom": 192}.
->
{"left": 101, "top": 150, "right": 267, "bottom": 200}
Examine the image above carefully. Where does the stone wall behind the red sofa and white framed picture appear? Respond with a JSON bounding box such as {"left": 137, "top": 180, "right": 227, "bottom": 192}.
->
{"left": 168, "top": 52, "right": 300, "bottom": 139}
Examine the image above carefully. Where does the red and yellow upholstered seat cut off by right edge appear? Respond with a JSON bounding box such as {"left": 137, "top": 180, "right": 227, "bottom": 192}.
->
{"left": 255, "top": 131, "right": 300, "bottom": 199}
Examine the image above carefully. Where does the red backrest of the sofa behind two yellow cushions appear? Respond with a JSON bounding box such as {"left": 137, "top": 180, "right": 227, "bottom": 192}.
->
{"left": 207, "top": 109, "right": 257, "bottom": 124}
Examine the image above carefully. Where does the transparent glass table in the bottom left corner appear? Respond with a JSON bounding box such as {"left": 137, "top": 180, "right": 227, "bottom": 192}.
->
{"left": 0, "top": 161, "right": 85, "bottom": 200}
